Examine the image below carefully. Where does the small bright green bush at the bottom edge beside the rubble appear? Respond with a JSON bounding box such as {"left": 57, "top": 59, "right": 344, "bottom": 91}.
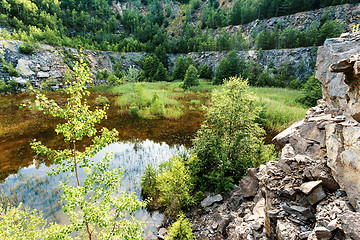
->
{"left": 165, "top": 213, "right": 195, "bottom": 240}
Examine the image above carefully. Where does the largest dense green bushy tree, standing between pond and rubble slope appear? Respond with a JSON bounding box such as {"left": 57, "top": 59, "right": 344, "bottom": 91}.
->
{"left": 193, "top": 78, "right": 272, "bottom": 192}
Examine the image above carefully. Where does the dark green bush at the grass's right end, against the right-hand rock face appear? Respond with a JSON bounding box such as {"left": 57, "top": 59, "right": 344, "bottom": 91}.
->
{"left": 296, "top": 75, "right": 322, "bottom": 107}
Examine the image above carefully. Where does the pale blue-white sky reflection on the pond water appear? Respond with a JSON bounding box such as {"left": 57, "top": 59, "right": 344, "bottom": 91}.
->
{"left": 0, "top": 140, "right": 186, "bottom": 239}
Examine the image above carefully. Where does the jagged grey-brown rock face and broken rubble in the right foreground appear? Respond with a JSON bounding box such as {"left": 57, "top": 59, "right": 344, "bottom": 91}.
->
{"left": 189, "top": 34, "right": 360, "bottom": 240}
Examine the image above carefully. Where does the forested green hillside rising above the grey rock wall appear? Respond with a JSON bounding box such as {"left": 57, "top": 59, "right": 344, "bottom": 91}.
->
{"left": 0, "top": 0, "right": 360, "bottom": 53}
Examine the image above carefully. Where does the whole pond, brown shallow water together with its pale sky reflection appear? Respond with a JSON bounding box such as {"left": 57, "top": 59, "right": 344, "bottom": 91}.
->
{"left": 0, "top": 92, "right": 205, "bottom": 239}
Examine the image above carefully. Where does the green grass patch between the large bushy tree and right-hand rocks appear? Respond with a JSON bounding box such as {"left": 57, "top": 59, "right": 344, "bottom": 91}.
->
{"left": 251, "top": 87, "right": 308, "bottom": 132}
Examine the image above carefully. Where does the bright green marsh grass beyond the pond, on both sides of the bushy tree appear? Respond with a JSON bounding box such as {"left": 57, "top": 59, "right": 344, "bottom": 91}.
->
{"left": 92, "top": 82, "right": 308, "bottom": 132}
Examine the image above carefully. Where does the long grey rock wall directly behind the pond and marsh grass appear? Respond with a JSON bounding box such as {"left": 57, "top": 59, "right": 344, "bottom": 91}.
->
{"left": 0, "top": 40, "right": 316, "bottom": 87}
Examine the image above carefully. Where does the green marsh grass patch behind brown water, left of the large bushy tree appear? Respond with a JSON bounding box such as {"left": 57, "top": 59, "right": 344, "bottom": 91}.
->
{"left": 92, "top": 79, "right": 216, "bottom": 120}
